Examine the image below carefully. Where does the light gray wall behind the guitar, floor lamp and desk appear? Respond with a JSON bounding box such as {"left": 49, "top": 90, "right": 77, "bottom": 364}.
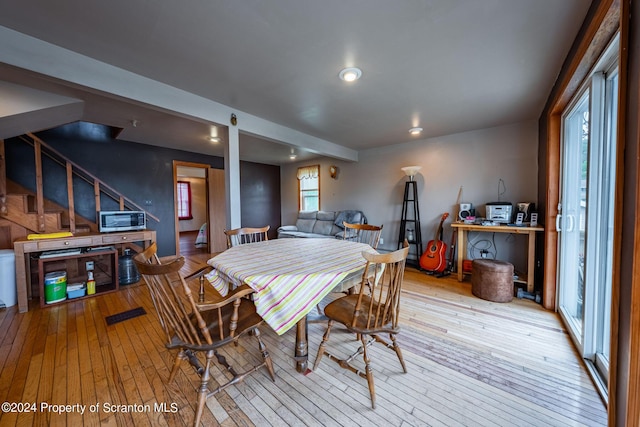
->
{"left": 281, "top": 121, "right": 538, "bottom": 271}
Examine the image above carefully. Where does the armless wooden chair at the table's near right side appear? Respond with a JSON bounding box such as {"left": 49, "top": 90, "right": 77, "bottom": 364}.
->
{"left": 313, "top": 240, "right": 409, "bottom": 409}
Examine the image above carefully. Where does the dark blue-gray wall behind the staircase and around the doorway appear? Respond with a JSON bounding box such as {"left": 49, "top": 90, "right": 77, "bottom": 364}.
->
{"left": 5, "top": 123, "right": 280, "bottom": 256}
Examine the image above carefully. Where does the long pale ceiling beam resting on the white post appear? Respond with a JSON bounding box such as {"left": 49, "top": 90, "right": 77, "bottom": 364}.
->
{"left": 0, "top": 26, "right": 358, "bottom": 161}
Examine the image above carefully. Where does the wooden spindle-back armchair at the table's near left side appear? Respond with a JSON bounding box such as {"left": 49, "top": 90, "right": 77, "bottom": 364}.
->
{"left": 133, "top": 244, "right": 275, "bottom": 426}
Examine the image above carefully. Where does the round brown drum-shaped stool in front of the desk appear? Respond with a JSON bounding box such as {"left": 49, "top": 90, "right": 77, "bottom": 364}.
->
{"left": 471, "top": 259, "right": 513, "bottom": 302}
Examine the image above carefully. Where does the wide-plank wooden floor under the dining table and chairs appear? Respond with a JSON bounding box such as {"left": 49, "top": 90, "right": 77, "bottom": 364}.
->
{"left": 0, "top": 255, "right": 606, "bottom": 427}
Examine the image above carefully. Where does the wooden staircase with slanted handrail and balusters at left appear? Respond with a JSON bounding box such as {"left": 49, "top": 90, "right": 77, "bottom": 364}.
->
{"left": 0, "top": 134, "right": 159, "bottom": 249}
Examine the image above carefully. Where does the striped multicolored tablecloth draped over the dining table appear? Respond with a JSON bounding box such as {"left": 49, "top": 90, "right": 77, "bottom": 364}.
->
{"left": 207, "top": 238, "right": 373, "bottom": 335}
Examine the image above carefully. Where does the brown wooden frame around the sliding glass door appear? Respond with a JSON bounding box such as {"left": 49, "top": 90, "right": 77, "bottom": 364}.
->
{"left": 539, "top": 0, "right": 628, "bottom": 426}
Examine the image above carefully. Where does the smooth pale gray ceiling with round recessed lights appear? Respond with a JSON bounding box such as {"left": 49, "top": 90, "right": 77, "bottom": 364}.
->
{"left": 0, "top": 0, "right": 591, "bottom": 164}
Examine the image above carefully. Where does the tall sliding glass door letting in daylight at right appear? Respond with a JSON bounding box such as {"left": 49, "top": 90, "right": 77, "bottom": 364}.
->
{"left": 556, "top": 36, "right": 618, "bottom": 392}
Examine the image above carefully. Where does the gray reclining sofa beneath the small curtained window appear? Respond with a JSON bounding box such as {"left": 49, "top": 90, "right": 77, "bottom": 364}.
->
{"left": 278, "top": 210, "right": 367, "bottom": 239}
